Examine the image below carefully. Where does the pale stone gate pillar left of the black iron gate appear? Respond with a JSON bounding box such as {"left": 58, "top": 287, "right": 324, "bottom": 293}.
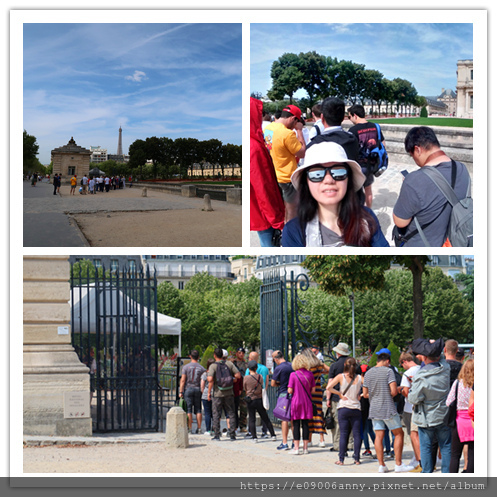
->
{"left": 23, "top": 255, "right": 92, "bottom": 436}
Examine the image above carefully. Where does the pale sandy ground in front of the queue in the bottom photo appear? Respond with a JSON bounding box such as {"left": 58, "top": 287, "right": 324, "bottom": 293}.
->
{"left": 23, "top": 421, "right": 430, "bottom": 477}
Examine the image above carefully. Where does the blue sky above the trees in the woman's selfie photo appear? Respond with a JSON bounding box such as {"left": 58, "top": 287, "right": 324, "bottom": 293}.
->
{"left": 250, "top": 23, "right": 473, "bottom": 101}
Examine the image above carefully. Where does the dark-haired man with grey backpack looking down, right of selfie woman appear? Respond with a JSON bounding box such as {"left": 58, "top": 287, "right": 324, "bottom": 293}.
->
{"left": 393, "top": 126, "right": 473, "bottom": 247}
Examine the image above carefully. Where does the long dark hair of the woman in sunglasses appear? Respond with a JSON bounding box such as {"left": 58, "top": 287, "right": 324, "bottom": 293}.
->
{"left": 298, "top": 164, "right": 376, "bottom": 247}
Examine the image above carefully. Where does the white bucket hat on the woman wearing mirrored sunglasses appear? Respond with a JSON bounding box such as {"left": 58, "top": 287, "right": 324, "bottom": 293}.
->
{"left": 292, "top": 142, "right": 366, "bottom": 191}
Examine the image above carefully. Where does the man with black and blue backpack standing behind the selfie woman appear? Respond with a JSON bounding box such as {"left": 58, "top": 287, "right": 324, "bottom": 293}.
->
{"left": 348, "top": 104, "right": 388, "bottom": 209}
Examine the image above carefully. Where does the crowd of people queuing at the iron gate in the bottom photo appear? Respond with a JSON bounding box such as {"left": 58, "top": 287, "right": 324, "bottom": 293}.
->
{"left": 179, "top": 339, "right": 474, "bottom": 473}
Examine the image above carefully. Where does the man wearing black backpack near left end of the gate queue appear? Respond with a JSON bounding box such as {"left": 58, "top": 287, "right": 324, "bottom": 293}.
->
{"left": 207, "top": 347, "right": 242, "bottom": 441}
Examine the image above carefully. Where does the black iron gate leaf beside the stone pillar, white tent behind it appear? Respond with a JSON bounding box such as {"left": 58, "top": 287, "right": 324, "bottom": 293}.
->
{"left": 71, "top": 261, "right": 158, "bottom": 432}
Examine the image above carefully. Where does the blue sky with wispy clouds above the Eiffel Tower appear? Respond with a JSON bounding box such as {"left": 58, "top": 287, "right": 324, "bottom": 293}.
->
{"left": 23, "top": 23, "right": 242, "bottom": 164}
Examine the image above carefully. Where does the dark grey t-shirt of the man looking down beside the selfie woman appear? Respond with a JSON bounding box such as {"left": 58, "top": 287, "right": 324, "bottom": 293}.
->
{"left": 393, "top": 161, "right": 470, "bottom": 247}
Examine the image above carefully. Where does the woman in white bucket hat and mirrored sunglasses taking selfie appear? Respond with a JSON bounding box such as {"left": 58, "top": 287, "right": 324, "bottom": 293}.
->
{"left": 281, "top": 142, "right": 389, "bottom": 247}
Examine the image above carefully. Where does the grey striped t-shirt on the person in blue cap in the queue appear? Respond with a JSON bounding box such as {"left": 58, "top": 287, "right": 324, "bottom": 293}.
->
{"left": 364, "top": 366, "right": 397, "bottom": 419}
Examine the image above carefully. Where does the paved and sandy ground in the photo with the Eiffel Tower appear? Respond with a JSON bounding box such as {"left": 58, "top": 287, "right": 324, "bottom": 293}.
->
{"left": 23, "top": 180, "right": 242, "bottom": 247}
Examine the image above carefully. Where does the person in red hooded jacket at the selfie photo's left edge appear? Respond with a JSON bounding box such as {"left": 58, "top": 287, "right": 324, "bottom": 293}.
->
{"left": 250, "top": 97, "right": 285, "bottom": 247}
